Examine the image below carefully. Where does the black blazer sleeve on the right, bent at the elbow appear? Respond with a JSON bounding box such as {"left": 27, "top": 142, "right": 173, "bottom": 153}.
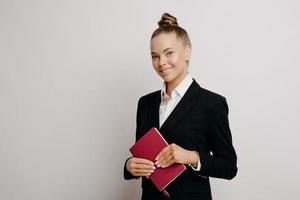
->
{"left": 199, "top": 97, "right": 237, "bottom": 180}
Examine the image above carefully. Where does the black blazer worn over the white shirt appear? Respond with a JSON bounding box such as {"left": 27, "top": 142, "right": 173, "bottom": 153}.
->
{"left": 124, "top": 80, "right": 237, "bottom": 200}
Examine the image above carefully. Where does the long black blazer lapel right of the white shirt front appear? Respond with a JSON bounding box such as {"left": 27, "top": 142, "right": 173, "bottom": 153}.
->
{"left": 157, "top": 80, "right": 199, "bottom": 134}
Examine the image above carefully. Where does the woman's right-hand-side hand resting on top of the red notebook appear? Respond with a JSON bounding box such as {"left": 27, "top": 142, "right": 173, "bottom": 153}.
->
{"left": 155, "top": 144, "right": 199, "bottom": 168}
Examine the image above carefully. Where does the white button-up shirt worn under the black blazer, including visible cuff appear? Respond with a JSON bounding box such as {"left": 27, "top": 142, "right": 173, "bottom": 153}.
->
{"left": 159, "top": 74, "right": 201, "bottom": 171}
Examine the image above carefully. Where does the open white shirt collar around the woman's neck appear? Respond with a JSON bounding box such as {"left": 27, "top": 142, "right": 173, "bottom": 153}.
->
{"left": 161, "top": 74, "right": 193, "bottom": 100}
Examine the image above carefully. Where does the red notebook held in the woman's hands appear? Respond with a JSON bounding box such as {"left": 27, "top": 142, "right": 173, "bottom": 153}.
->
{"left": 129, "top": 128, "right": 186, "bottom": 191}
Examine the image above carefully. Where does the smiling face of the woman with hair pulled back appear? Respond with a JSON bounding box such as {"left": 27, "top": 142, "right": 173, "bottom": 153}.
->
{"left": 150, "top": 33, "right": 191, "bottom": 85}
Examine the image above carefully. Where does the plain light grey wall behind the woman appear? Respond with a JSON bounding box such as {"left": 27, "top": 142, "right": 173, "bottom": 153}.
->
{"left": 0, "top": 0, "right": 300, "bottom": 200}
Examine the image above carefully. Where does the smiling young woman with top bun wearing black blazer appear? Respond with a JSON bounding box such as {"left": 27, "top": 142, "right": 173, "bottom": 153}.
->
{"left": 124, "top": 13, "right": 237, "bottom": 200}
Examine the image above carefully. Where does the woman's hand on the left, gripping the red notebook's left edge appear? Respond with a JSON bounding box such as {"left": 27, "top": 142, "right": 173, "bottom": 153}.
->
{"left": 126, "top": 157, "right": 155, "bottom": 178}
